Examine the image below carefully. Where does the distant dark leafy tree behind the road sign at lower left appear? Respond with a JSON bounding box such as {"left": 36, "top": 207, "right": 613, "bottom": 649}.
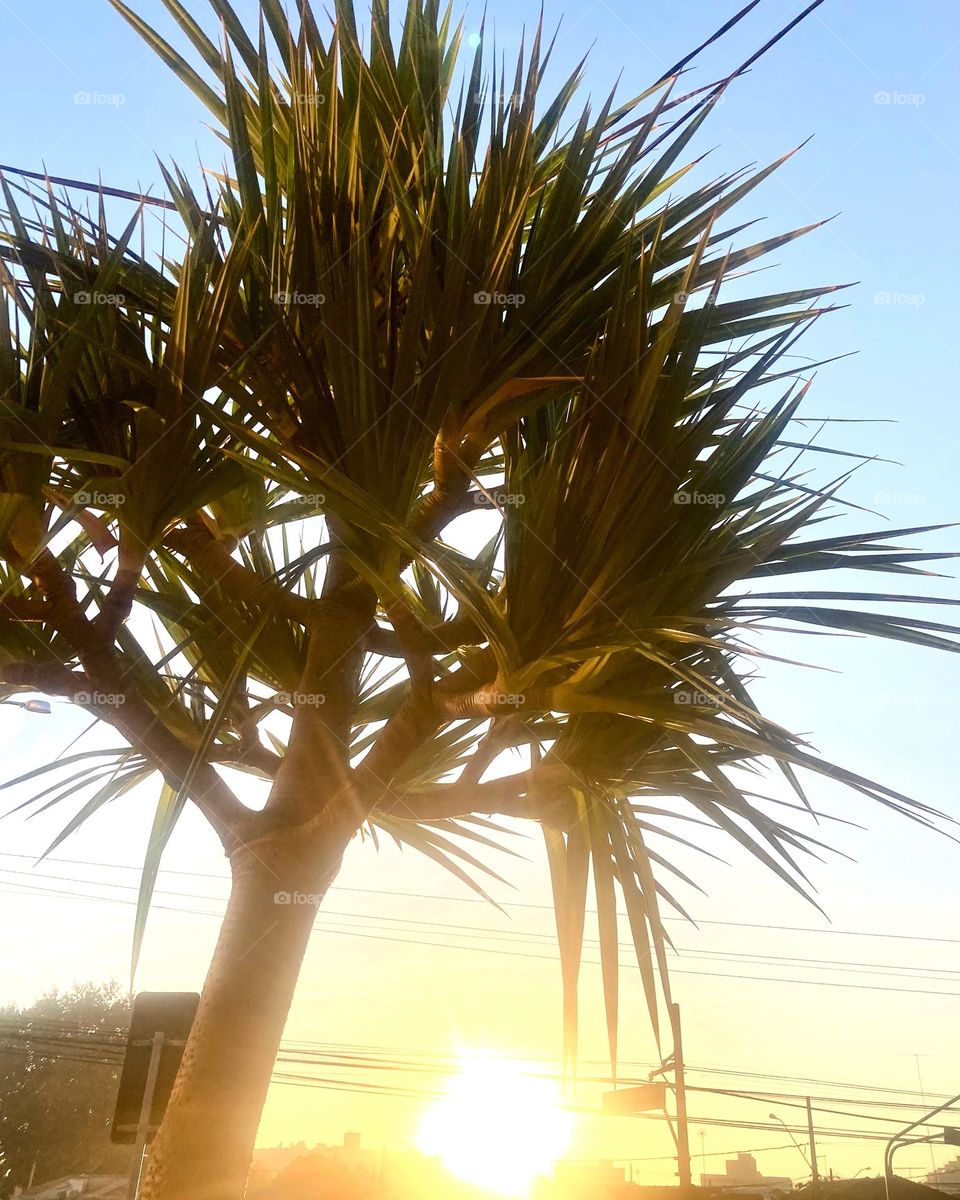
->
{"left": 0, "top": 983, "right": 130, "bottom": 1200}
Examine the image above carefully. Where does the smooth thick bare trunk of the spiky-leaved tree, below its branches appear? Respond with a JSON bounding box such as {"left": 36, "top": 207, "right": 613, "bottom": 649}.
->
{"left": 140, "top": 835, "right": 343, "bottom": 1200}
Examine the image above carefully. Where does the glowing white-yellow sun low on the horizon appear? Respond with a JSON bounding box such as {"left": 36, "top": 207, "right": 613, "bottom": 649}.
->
{"left": 416, "top": 1051, "right": 574, "bottom": 1196}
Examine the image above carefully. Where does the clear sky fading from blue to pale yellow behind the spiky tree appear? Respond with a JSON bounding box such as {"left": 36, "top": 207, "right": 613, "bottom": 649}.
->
{"left": 0, "top": 0, "right": 960, "bottom": 1182}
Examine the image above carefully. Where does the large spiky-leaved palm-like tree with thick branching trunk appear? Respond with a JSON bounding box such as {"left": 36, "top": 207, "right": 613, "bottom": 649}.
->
{"left": 0, "top": 0, "right": 958, "bottom": 1200}
